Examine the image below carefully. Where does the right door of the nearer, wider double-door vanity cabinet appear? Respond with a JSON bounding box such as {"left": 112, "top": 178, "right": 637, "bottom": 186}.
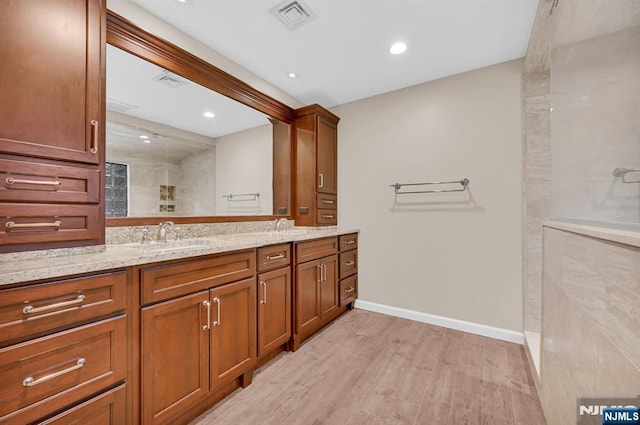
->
{"left": 211, "top": 277, "right": 256, "bottom": 388}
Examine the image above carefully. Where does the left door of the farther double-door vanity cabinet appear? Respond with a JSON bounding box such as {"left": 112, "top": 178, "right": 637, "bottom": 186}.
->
{"left": 296, "top": 260, "right": 322, "bottom": 334}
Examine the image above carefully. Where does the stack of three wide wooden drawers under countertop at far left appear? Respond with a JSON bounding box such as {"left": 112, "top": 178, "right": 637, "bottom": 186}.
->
{"left": 0, "top": 271, "right": 128, "bottom": 425}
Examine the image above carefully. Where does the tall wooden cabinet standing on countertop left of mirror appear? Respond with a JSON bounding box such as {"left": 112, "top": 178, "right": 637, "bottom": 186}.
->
{"left": 0, "top": 0, "right": 106, "bottom": 252}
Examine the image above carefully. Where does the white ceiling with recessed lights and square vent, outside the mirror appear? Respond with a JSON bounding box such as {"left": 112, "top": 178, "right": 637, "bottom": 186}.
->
{"left": 127, "top": 0, "right": 538, "bottom": 107}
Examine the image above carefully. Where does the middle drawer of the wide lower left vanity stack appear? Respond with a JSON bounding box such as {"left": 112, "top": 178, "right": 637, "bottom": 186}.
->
{"left": 0, "top": 316, "right": 127, "bottom": 424}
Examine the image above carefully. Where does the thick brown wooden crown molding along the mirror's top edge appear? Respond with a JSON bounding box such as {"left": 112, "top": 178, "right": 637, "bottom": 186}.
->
{"left": 107, "top": 10, "right": 295, "bottom": 123}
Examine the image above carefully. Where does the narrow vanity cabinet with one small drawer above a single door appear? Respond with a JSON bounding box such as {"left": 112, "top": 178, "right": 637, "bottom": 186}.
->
{"left": 257, "top": 243, "right": 292, "bottom": 359}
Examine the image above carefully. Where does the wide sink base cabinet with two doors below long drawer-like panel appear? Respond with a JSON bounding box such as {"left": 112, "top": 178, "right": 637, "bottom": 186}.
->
{"left": 139, "top": 250, "right": 257, "bottom": 425}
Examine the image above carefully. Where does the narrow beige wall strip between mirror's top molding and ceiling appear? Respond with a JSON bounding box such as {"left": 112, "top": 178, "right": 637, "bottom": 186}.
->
{"left": 107, "top": 0, "right": 304, "bottom": 108}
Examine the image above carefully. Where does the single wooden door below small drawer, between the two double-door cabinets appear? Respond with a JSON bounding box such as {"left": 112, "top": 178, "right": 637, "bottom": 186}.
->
{"left": 258, "top": 267, "right": 291, "bottom": 356}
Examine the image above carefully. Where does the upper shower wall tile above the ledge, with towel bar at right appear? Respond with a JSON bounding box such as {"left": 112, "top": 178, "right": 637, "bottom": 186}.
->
{"left": 551, "top": 26, "right": 640, "bottom": 224}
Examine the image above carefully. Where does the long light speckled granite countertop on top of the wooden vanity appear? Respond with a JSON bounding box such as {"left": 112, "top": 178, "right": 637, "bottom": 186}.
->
{"left": 0, "top": 228, "right": 359, "bottom": 286}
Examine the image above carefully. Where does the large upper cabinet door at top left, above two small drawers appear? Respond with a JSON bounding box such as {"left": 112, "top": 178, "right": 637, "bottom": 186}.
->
{"left": 0, "top": 0, "right": 105, "bottom": 164}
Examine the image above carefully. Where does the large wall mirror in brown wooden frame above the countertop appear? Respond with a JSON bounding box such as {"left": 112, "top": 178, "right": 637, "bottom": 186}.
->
{"left": 105, "top": 12, "right": 293, "bottom": 226}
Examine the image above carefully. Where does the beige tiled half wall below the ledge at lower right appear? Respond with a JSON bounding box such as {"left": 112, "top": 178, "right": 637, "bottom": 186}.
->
{"left": 539, "top": 227, "right": 640, "bottom": 425}
